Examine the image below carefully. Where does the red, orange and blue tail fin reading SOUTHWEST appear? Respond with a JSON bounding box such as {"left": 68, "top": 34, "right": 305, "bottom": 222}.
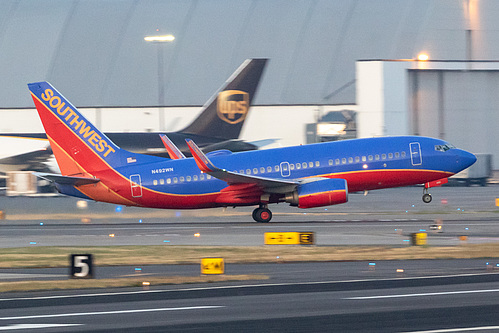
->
{"left": 28, "top": 82, "right": 161, "bottom": 179}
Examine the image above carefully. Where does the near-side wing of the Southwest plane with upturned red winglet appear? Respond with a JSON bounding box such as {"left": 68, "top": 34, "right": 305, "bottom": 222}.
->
{"left": 186, "top": 140, "right": 301, "bottom": 193}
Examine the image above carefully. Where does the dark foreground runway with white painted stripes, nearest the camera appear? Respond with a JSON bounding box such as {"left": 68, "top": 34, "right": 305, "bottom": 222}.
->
{"left": 0, "top": 273, "right": 499, "bottom": 332}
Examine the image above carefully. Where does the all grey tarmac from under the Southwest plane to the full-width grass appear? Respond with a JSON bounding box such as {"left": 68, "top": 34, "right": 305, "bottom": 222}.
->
{"left": 0, "top": 186, "right": 499, "bottom": 247}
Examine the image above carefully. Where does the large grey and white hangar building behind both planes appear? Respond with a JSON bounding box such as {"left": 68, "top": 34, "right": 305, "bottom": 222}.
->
{"left": 0, "top": 0, "right": 499, "bottom": 169}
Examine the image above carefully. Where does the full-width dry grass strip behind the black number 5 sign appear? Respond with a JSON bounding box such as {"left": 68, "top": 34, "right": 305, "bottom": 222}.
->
{"left": 0, "top": 243, "right": 499, "bottom": 268}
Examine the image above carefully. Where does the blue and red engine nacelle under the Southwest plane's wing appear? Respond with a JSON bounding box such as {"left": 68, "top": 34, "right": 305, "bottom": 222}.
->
{"left": 286, "top": 179, "right": 348, "bottom": 208}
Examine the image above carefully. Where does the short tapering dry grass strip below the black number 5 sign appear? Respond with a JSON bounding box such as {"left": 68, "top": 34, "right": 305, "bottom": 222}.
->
{"left": 0, "top": 275, "right": 268, "bottom": 292}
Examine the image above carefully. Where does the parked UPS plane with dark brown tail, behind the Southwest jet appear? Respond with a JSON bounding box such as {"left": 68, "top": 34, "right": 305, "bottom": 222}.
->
{"left": 0, "top": 59, "right": 275, "bottom": 172}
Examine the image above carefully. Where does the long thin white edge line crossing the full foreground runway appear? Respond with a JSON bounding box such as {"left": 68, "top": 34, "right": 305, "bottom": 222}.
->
{"left": 0, "top": 273, "right": 499, "bottom": 303}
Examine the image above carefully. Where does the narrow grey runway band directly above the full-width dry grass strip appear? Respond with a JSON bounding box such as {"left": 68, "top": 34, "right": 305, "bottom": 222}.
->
{"left": 0, "top": 219, "right": 499, "bottom": 247}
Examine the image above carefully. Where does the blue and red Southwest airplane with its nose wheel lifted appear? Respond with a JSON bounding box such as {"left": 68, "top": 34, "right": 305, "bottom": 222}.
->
{"left": 28, "top": 82, "right": 476, "bottom": 222}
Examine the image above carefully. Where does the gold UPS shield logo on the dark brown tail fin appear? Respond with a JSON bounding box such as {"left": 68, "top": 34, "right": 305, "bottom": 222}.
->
{"left": 217, "top": 90, "right": 249, "bottom": 124}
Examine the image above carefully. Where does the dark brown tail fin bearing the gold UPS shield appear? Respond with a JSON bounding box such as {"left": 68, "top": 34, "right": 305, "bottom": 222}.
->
{"left": 180, "top": 59, "right": 268, "bottom": 140}
